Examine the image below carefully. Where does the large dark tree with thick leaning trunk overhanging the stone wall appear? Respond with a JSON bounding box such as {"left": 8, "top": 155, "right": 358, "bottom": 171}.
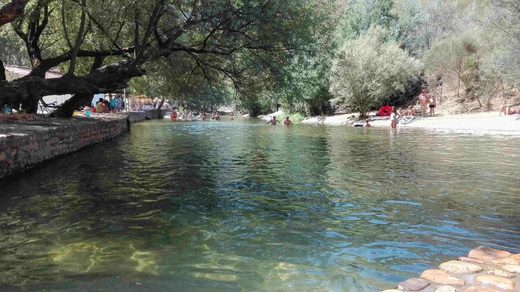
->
{"left": 0, "top": 0, "right": 322, "bottom": 116}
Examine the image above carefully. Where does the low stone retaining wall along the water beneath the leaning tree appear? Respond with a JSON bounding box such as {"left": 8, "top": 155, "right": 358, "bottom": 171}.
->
{"left": 0, "top": 114, "right": 129, "bottom": 178}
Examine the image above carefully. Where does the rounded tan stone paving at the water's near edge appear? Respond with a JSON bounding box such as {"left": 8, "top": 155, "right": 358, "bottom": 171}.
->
{"left": 383, "top": 247, "right": 520, "bottom": 292}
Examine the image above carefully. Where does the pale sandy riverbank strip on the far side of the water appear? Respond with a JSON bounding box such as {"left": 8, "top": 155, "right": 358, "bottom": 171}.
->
{"left": 302, "top": 112, "right": 520, "bottom": 135}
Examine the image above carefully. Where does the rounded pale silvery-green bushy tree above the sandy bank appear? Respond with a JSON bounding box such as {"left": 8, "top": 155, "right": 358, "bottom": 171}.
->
{"left": 331, "top": 27, "right": 421, "bottom": 114}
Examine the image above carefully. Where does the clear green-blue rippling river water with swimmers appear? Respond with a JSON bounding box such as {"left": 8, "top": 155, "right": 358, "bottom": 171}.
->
{"left": 0, "top": 121, "right": 520, "bottom": 291}
